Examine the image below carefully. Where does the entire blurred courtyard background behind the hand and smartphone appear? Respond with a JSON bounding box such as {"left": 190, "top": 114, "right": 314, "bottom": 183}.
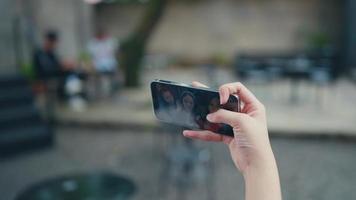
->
{"left": 0, "top": 0, "right": 356, "bottom": 200}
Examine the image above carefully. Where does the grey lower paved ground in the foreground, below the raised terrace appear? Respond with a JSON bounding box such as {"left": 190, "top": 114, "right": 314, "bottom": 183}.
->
{"left": 0, "top": 128, "right": 356, "bottom": 200}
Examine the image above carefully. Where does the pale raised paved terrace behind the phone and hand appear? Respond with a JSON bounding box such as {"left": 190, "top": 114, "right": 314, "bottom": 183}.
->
{"left": 58, "top": 67, "right": 356, "bottom": 136}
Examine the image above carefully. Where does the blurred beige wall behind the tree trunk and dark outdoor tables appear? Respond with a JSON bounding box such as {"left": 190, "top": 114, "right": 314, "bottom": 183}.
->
{"left": 96, "top": 0, "right": 343, "bottom": 59}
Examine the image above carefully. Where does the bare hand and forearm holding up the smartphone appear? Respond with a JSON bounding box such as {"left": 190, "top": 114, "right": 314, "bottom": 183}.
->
{"left": 183, "top": 82, "right": 282, "bottom": 200}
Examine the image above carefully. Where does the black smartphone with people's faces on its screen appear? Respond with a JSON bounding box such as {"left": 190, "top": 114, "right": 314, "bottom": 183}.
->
{"left": 151, "top": 80, "right": 240, "bottom": 136}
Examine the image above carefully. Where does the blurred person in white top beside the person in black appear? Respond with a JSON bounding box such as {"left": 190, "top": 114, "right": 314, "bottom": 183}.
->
{"left": 88, "top": 28, "right": 119, "bottom": 97}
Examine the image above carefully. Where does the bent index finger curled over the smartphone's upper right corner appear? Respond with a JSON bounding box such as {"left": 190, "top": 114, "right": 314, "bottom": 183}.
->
{"left": 219, "top": 82, "right": 262, "bottom": 107}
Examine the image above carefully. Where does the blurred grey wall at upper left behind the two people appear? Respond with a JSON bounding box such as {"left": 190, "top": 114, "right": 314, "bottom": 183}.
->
{"left": 0, "top": 0, "right": 93, "bottom": 74}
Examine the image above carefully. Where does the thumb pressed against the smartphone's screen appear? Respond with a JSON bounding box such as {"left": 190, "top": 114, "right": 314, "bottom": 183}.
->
{"left": 206, "top": 109, "right": 248, "bottom": 128}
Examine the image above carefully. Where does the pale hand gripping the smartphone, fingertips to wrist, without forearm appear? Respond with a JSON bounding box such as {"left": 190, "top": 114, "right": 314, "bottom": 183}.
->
{"left": 183, "top": 82, "right": 273, "bottom": 174}
